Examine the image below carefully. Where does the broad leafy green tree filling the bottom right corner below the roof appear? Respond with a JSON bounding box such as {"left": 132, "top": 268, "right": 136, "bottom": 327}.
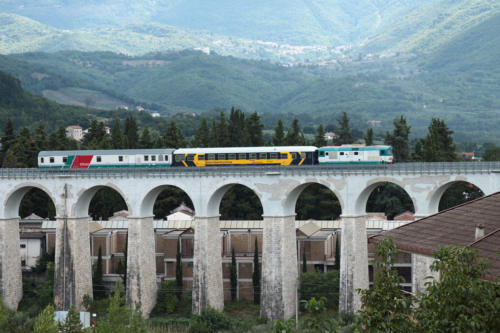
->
{"left": 415, "top": 246, "right": 500, "bottom": 332}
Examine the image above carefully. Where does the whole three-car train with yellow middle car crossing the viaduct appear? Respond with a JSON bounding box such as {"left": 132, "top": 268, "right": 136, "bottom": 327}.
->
{"left": 38, "top": 145, "right": 393, "bottom": 169}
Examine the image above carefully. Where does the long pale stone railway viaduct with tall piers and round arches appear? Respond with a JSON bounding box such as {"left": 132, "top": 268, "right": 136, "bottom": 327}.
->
{"left": 0, "top": 162, "right": 500, "bottom": 319}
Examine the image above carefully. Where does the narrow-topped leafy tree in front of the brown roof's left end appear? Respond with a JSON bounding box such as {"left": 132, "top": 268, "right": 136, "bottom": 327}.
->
{"left": 358, "top": 238, "right": 414, "bottom": 332}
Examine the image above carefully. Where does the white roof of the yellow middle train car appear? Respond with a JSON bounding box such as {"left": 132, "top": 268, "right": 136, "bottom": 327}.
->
{"left": 174, "top": 146, "right": 318, "bottom": 154}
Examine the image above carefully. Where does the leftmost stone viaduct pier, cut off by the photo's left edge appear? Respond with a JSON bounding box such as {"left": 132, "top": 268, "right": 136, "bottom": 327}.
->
{"left": 0, "top": 218, "right": 23, "bottom": 310}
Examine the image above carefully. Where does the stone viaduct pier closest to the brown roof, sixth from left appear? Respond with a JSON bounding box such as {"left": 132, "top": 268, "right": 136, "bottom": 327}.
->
{"left": 339, "top": 216, "right": 369, "bottom": 313}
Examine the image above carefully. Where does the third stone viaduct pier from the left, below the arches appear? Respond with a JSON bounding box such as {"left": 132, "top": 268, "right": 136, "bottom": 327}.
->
{"left": 127, "top": 216, "right": 157, "bottom": 317}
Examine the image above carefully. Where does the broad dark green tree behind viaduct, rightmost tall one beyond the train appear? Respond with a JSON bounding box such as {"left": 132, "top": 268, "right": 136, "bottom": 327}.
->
{"left": 422, "top": 118, "right": 457, "bottom": 162}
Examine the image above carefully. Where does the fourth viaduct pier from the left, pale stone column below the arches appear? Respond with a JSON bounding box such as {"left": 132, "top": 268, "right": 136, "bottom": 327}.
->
{"left": 193, "top": 216, "right": 224, "bottom": 314}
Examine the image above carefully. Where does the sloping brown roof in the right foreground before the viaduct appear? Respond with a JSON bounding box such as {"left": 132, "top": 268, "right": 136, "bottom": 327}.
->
{"left": 370, "top": 192, "right": 500, "bottom": 276}
